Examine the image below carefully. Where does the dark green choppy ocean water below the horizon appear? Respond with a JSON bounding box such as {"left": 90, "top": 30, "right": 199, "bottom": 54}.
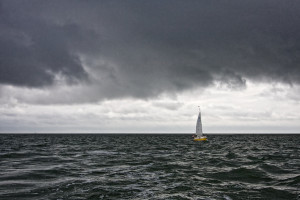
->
{"left": 0, "top": 134, "right": 300, "bottom": 200}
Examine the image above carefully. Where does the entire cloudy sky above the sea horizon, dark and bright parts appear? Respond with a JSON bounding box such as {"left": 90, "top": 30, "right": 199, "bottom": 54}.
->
{"left": 0, "top": 0, "right": 300, "bottom": 134}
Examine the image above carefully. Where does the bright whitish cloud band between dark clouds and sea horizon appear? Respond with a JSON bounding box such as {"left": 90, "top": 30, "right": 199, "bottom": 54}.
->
{"left": 0, "top": 82, "right": 300, "bottom": 133}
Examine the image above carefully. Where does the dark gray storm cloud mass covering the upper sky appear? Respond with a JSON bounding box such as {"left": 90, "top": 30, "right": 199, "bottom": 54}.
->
{"left": 0, "top": 0, "right": 300, "bottom": 99}
